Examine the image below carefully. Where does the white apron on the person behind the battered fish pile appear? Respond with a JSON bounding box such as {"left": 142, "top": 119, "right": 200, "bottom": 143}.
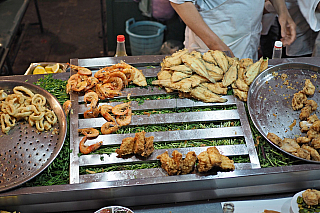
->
{"left": 185, "top": 0, "right": 264, "bottom": 59}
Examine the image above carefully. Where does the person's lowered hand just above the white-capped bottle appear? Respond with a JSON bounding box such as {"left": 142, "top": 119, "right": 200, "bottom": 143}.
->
{"left": 278, "top": 14, "right": 296, "bottom": 46}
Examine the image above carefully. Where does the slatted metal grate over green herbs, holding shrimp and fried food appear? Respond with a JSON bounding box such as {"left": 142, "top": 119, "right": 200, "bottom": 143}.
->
{"left": 70, "top": 56, "right": 260, "bottom": 184}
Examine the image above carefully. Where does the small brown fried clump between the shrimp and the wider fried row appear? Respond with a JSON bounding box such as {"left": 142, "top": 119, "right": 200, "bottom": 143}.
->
{"left": 116, "top": 131, "right": 154, "bottom": 157}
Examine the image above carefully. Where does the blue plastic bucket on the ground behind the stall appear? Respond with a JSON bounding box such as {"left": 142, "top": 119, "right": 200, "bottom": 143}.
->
{"left": 126, "top": 18, "right": 166, "bottom": 55}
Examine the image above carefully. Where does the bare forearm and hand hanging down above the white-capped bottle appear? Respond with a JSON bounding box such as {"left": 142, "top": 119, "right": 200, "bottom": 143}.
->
{"left": 270, "top": 0, "right": 296, "bottom": 46}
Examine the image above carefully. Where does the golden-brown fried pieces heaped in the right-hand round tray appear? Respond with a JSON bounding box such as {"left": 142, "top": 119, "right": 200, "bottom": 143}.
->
{"left": 267, "top": 79, "right": 320, "bottom": 161}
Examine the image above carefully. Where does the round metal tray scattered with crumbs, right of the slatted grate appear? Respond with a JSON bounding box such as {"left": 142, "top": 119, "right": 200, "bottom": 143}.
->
{"left": 248, "top": 63, "right": 320, "bottom": 163}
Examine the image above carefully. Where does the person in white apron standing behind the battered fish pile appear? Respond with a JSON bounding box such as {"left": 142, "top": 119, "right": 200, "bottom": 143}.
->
{"left": 170, "top": 0, "right": 295, "bottom": 59}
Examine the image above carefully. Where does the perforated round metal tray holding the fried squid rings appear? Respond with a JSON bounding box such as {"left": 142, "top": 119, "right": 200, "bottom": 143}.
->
{"left": 0, "top": 80, "right": 67, "bottom": 191}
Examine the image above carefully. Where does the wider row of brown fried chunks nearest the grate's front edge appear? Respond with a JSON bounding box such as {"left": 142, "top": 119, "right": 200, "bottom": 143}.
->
{"left": 157, "top": 147, "right": 235, "bottom": 175}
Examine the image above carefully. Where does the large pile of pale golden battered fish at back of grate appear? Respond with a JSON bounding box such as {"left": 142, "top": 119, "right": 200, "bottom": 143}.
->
{"left": 152, "top": 49, "right": 268, "bottom": 102}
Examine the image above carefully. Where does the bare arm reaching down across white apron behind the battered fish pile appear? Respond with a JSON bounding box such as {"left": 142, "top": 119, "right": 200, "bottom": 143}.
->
{"left": 171, "top": 2, "right": 234, "bottom": 57}
